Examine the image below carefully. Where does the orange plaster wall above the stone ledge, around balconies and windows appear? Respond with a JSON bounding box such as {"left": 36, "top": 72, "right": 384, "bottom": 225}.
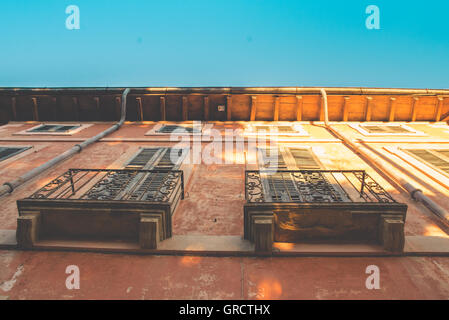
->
{"left": 0, "top": 122, "right": 449, "bottom": 236}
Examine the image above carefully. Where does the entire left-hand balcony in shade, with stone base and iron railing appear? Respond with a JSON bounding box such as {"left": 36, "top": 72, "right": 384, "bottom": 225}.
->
{"left": 17, "top": 169, "right": 184, "bottom": 249}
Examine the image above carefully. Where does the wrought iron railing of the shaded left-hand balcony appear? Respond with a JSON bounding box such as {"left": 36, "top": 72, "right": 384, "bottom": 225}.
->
{"left": 27, "top": 169, "right": 184, "bottom": 202}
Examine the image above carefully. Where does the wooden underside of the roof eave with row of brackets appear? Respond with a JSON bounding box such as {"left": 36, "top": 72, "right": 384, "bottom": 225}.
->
{"left": 0, "top": 88, "right": 449, "bottom": 123}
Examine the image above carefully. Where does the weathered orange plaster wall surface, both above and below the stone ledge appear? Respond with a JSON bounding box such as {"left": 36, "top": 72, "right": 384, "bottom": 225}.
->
{"left": 0, "top": 122, "right": 449, "bottom": 299}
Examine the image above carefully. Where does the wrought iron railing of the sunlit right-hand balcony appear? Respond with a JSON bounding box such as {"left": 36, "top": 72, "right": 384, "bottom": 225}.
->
{"left": 245, "top": 170, "right": 396, "bottom": 203}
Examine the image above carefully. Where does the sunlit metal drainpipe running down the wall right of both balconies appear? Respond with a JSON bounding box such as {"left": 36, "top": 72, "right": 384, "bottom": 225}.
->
{"left": 321, "top": 89, "right": 449, "bottom": 226}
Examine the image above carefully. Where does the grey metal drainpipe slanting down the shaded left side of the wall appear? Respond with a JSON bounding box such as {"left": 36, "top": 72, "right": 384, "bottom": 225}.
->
{"left": 0, "top": 88, "right": 130, "bottom": 197}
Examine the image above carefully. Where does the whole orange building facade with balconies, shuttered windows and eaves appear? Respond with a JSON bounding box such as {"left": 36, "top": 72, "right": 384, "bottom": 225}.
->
{"left": 0, "top": 88, "right": 449, "bottom": 299}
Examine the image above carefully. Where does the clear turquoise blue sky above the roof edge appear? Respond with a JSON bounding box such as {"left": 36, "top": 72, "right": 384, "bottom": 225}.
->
{"left": 0, "top": 0, "right": 449, "bottom": 88}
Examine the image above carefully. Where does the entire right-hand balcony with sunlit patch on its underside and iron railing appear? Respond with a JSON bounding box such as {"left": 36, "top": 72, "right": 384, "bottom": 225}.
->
{"left": 244, "top": 170, "right": 407, "bottom": 252}
